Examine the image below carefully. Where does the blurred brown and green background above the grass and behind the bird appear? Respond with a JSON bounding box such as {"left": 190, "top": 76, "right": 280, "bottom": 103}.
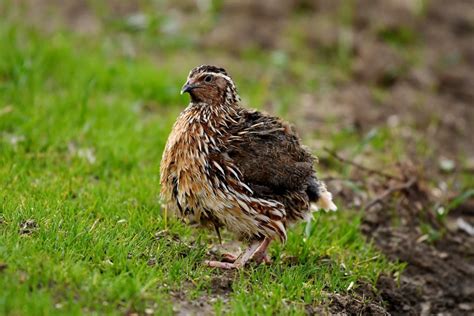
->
{"left": 0, "top": 0, "right": 474, "bottom": 159}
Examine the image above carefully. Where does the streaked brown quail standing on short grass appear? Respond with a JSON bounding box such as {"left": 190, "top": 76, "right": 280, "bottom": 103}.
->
{"left": 160, "top": 65, "right": 337, "bottom": 269}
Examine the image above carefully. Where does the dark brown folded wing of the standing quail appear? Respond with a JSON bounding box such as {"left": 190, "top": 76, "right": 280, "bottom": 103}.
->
{"left": 226, "top": 110, "right": 314, "bottom": 196}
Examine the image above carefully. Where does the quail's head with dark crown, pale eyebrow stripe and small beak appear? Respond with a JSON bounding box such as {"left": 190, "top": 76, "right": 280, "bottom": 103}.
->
{"left": 181, "top": 65, "right": 240, "bottom": 105}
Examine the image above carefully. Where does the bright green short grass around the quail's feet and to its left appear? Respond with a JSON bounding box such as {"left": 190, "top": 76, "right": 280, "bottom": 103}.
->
{"left": 0, "top": 10, "right": 400, "bottom": 315}
